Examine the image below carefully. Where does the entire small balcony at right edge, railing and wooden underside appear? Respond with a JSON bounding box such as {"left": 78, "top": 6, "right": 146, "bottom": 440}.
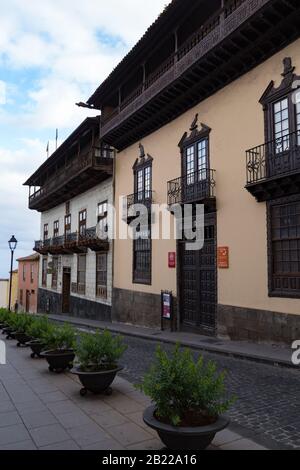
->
{"left": 246, "top": 131, "right": 300, "bottom": 202}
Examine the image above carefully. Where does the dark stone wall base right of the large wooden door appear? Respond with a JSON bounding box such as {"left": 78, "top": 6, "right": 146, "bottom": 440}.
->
{"left": 218, "top": 305, "right": 300, "bottom": 346}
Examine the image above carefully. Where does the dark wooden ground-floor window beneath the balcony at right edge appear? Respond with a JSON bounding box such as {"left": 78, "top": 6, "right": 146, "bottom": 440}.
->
{"left": 269, "top": 196, "right": 300, "bottom": 298}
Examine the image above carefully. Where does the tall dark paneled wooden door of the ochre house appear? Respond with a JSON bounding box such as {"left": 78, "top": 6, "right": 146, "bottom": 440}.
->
{"left": 180, "top": 214, "right": 217, "bottom": 335}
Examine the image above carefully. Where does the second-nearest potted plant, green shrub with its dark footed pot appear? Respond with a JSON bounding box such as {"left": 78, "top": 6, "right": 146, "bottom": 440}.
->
{"left": 71, "top": 331, "right": 126, "bottom": 396}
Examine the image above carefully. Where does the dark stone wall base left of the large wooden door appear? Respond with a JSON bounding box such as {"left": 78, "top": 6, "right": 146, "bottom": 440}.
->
{"left": 112, "top": 289, "right": 176, "bottom": 330}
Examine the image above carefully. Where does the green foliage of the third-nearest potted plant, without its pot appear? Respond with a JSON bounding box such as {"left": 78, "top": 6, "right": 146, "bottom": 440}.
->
{"left": 41, "top": 324, "right": 76, "bottom": 351}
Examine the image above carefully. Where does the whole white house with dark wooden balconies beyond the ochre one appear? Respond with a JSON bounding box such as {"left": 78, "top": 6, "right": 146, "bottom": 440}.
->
{"left": 26, "top": 117, "right": 114, "bottom": 320}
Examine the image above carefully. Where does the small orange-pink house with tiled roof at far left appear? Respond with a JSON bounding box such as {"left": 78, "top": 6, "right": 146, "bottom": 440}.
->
{"left": 17, "top": 254, "right": 40, "bottom": 313}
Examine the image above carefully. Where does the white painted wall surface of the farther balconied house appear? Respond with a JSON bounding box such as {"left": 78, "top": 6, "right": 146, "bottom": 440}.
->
{"left": 39, "top": 178, "right": 113, "bottom": 305}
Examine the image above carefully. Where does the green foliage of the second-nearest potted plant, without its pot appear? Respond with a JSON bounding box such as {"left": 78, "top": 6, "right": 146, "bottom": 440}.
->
{"left": 76, "top": 331, "right": 127, "bottom": 372}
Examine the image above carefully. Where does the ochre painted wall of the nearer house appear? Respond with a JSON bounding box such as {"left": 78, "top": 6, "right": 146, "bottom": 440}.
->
{"left": 114, "top": 36, "right": 300, "bottom": 314}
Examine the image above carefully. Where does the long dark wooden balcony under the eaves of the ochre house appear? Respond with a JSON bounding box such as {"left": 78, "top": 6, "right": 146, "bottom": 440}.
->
{"left": 98, "top": 0, "right": 300, "bottom": 150}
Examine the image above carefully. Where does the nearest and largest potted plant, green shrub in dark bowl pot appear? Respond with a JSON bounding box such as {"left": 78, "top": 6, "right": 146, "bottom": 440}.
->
{"left": 137, "top": 345, "right": 233, "bottom": 450}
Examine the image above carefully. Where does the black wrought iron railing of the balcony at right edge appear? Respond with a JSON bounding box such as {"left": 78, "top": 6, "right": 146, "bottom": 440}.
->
{"left": 246, "top": 130, "right": 300, "bottom": 185}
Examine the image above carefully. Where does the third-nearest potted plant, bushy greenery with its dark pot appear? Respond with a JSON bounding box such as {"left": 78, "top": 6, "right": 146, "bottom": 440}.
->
{"left": 41, "top": 324, "right": 76, "bottom": 373}
